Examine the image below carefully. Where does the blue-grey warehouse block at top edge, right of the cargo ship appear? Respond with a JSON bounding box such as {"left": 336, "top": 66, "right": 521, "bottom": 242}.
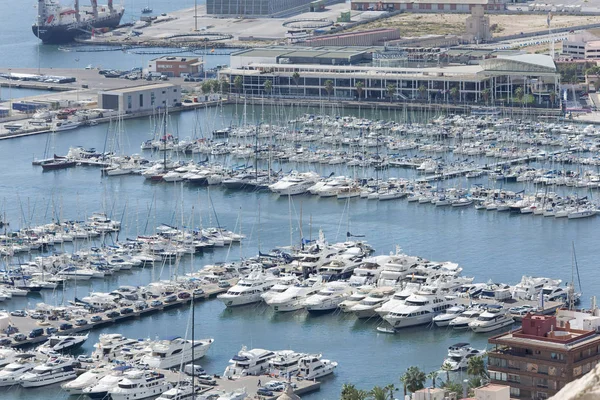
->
{"left": 206, "top": 0, "right": 324, "bottom": 17}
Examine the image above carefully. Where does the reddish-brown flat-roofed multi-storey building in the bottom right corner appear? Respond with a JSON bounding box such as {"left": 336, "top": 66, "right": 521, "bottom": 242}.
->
{"left": 487, "top": 311, "right": 600, "bottom": 399}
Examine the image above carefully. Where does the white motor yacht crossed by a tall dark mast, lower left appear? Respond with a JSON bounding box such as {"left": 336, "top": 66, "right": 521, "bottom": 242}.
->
{"left": 140, "top": 336, "right": 214, "bottom": 369}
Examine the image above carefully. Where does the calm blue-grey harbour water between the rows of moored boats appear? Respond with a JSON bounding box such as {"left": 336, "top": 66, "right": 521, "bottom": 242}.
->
{"left": 0, "top": 0, "right": 600, "bottom": 400}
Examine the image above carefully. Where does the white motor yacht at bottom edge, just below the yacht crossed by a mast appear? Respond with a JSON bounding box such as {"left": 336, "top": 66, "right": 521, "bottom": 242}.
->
{"left": 108, "top": 370, "right": 173, "bottom": 400}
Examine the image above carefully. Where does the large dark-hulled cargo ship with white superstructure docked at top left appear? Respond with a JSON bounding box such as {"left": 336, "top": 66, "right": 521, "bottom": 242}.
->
{"left": 32, "top": 0, "right": 125, "bottom": 44}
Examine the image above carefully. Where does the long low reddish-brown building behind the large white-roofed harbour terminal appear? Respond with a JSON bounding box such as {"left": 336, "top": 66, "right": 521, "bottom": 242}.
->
{"left": 298, "top": 28, "right": 400, "bottom": 47}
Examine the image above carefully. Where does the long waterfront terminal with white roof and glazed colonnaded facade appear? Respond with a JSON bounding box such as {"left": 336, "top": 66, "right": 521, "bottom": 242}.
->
{"left": 219, "top": 49, "right": 559, "bottom": 106}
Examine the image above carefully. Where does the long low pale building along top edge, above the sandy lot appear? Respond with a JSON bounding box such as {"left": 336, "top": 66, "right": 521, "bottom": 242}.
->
{"left": 351, "top": 0, "right": 506, "bottom": 13}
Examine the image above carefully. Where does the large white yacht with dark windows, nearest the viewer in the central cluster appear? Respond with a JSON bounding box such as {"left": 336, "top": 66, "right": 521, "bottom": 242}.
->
{"left": 383, "top": 291, "right": 456, "bottom": 329}
